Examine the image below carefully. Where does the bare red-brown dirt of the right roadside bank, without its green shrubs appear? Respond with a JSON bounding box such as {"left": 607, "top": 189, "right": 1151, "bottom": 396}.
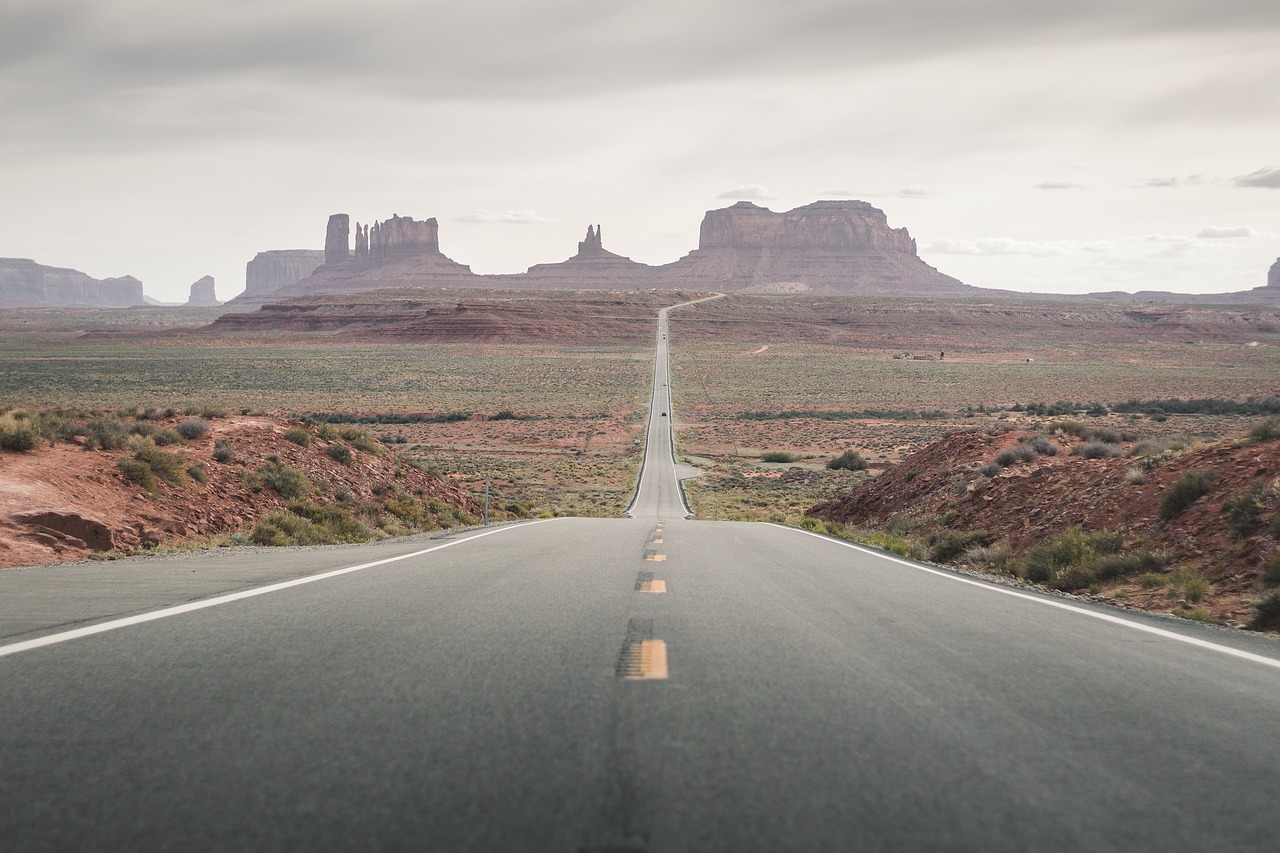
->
{"left": 810, "top": 422, "right": 1280, "bottom": 622}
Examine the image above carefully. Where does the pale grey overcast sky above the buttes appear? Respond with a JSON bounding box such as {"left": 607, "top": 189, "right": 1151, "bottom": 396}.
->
{"left": 0, "top": 0, "right": 1280, "bottom": 301}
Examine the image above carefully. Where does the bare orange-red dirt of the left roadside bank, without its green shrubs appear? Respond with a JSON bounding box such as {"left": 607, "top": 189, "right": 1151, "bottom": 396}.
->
{"left": 0, "top": 418, "right": 480, "bottom": 569}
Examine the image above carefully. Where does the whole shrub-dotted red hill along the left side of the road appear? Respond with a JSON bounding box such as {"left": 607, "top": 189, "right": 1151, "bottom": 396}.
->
{"left": 0, "top": 412, "right": 481, "bottom": 569}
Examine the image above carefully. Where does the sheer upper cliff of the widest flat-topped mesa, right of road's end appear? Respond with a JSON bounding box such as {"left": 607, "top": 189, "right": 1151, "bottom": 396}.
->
{"left": 698, "top": 201, "right": 915, "bottom": 255}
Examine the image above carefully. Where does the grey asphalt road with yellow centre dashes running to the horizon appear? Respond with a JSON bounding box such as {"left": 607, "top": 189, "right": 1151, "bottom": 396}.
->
{"left": 0, "top": 295, "right": 1280, "bottom": 852}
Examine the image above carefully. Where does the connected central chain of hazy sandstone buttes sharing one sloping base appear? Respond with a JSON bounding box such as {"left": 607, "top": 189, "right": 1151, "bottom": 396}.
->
{"left": 232, "top": 201, "right": 989, "bottom": 304}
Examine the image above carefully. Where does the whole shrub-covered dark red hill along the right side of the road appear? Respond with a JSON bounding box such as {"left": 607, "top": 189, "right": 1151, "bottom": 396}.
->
{"left": 810, "top": 417, "right": 1280, "bottom": 628}
